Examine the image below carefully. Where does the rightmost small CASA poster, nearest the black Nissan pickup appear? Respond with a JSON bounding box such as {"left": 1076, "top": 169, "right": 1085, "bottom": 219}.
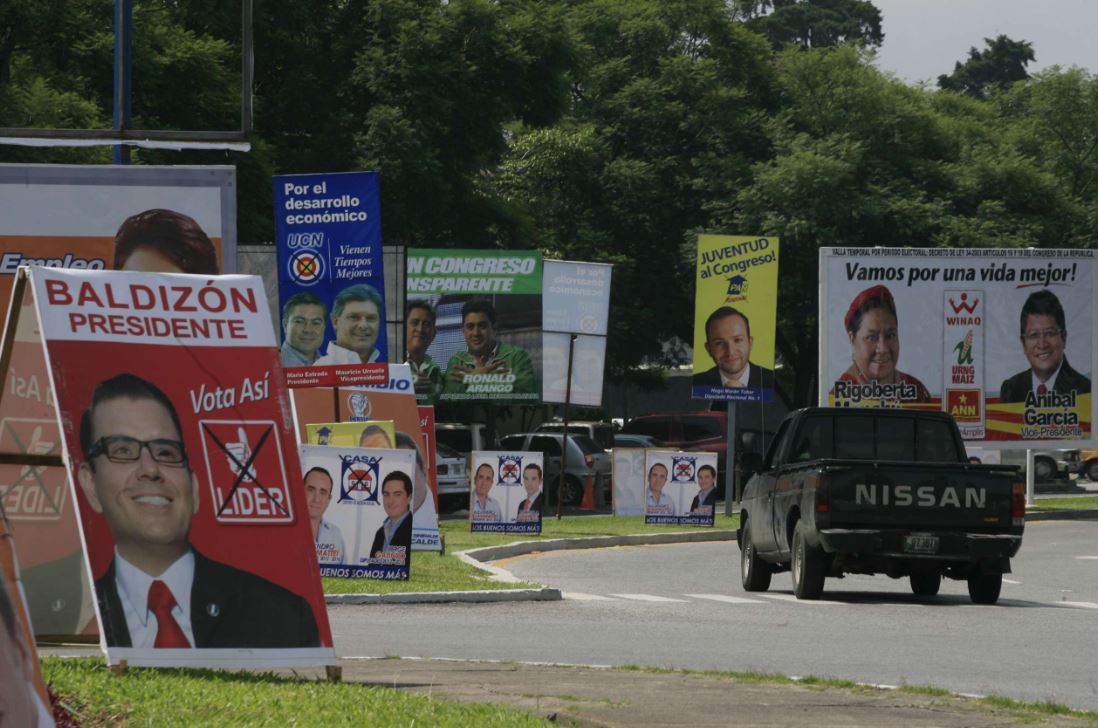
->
{"left": 643, "top": 450, "right": 717, "bottom": 526}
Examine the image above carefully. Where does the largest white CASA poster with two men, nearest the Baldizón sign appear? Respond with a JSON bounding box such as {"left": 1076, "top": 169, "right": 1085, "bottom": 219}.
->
{"left": 301, "top": 445, "right": 416, "bottom": 580}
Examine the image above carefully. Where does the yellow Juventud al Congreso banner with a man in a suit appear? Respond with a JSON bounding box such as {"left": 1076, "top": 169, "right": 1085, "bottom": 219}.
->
{"left": 691, "top": 235, "right": 778, "bottom": 402}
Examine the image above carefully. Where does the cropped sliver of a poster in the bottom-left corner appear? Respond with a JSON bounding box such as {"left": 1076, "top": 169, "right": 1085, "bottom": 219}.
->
{"left": 0, "top": 516, "right": 54, "bottom": 728}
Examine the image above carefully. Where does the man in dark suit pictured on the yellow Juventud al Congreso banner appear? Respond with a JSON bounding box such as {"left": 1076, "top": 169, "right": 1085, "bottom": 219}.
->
{"left": 692, "top": 306, "right": 774, "bottom": 389}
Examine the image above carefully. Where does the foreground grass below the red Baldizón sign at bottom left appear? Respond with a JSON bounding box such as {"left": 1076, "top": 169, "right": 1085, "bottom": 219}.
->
{"left": 42, "top": 657, "right": 551, "bottom": 728}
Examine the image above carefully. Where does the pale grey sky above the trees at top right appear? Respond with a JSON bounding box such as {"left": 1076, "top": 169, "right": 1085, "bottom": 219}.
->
{"left": 872, "top": 0, "right": 1098, "bottom": 85}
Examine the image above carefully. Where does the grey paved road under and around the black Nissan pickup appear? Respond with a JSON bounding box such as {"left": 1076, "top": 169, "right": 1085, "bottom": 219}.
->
{"left": 329, "top": 522, "right": 1098, "bottom": 710}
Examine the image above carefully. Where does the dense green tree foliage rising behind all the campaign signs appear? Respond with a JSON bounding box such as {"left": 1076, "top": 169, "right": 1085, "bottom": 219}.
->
{"left": 0, "top": 0, "right": 1098, "bottom": 404}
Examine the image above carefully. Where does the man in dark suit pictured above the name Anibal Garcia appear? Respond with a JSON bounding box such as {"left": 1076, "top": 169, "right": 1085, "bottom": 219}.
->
{"left": 999, "top": 289, "right": 1090, "bottom": 402}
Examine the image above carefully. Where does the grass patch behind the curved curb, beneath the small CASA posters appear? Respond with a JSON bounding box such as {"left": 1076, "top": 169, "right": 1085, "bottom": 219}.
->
{"left": 322, "top": 514, "right": 739, "bottom": 594}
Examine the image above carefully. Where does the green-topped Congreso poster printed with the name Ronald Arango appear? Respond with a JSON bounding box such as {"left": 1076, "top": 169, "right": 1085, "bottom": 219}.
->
{"left": 405, "top": 248, "right": 541, "bottom": 404}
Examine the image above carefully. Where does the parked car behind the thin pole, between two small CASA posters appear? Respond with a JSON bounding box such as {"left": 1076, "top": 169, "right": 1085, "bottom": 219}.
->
{"left": 500, "top": 433, "right": 613, "bottom": 505}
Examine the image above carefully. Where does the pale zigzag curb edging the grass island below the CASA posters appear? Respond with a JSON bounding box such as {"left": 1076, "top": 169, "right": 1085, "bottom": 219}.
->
{"left": 324, "top": 530, "right": 736, "bottom": 604}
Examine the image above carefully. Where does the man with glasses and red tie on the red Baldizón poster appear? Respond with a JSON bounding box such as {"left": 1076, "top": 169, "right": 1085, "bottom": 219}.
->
{"left": 78, "top": 373, "right": 320, "bottom": 648}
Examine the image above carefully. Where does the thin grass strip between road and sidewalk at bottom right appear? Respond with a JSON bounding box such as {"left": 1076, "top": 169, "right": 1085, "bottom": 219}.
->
{"left": 614, "top": 664, "right": 1098, "bottom": 725}
